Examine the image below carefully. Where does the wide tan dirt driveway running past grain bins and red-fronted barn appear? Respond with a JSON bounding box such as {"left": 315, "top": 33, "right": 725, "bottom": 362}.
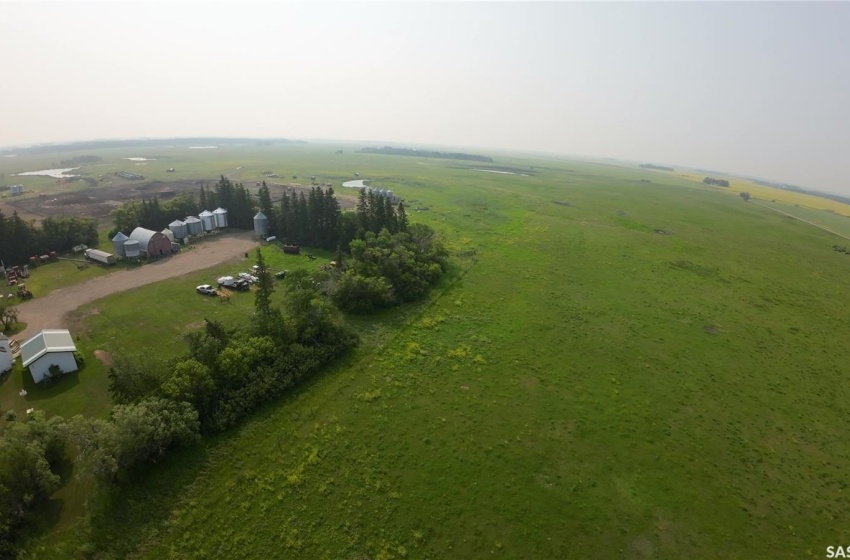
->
{"left": 14, "top": 232, "right": 257, "bottom": 343}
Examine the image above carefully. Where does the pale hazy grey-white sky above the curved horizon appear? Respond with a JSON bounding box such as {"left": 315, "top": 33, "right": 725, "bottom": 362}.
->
{"left": 0, "top": 2, "right": 850, "bottom": 194}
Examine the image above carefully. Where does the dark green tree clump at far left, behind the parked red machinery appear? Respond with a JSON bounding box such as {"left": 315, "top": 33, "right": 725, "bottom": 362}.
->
{"left": 0, "top": 211, "right": 97, "bottom": 266}
